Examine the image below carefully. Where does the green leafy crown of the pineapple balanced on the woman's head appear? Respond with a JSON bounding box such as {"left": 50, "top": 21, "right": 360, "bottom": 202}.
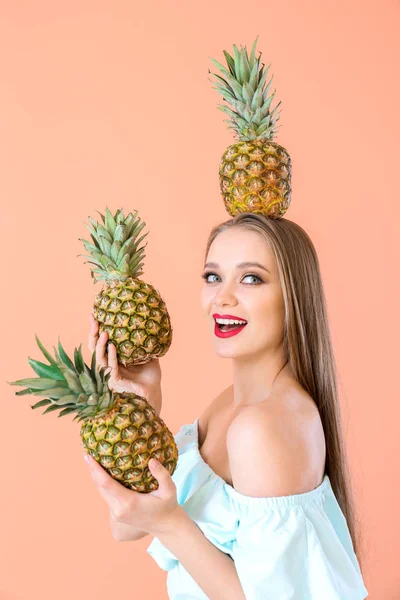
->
{"left": 208, "top": 36, "right": 281, "bottom": 141}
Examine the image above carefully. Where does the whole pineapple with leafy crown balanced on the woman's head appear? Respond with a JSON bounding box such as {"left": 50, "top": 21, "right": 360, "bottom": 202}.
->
{"left": 209, "top": 36, "right": 291, "bottom": 218}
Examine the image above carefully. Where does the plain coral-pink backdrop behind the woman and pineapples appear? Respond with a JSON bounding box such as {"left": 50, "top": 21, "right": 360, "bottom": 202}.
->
{"left": 0, "top": 0, "right": 400, "bottom": 600}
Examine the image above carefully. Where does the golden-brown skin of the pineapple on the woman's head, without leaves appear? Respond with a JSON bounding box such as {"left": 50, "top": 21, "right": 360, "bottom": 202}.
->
{"left": 219, "top": 139, "right": 292, "bottom": 218}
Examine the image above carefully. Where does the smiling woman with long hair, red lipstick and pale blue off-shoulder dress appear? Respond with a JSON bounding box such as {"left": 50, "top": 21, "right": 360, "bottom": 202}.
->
{"left": 85, "top": 213, "right": 368, "bottom": 600}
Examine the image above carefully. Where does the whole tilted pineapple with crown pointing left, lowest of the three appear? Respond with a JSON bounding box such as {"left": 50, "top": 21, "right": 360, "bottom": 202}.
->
{"left": 10, "top": 337, "right": 178, "bottom": 493}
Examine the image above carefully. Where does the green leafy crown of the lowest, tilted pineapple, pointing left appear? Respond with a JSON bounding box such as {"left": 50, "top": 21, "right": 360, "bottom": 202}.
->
{"left": 7, "top": 336, "right": 115, "bottom": 421}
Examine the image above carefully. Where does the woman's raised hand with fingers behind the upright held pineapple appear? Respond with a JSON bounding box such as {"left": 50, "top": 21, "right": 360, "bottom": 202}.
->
{"left": 89, "top": 313, "right": 161, "bottom": 414}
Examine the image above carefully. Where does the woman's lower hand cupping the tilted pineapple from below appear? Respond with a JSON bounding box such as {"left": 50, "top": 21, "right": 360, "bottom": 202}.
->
{"left": 85, "top": 454, "right": 182, "bottom": 541}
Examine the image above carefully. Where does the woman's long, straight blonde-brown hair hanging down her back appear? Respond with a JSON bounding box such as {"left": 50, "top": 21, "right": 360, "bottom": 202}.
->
{"left": 205, "top": 212, "right": 361, "bottom": 568}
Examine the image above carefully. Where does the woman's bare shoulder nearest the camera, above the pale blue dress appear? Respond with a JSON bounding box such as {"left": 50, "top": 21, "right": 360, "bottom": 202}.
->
{"left": 226, "top": 390, "right": 325, "bottom": 497}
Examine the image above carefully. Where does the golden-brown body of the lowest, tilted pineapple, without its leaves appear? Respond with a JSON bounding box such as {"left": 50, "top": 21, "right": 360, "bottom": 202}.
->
{"left": 80, "top": 392, "right": 178, "bottom": 493}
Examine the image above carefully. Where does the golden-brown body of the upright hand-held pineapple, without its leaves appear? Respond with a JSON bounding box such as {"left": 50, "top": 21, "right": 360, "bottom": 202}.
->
{"left": 93, "top": 277, "right": 172, "bottom": 367}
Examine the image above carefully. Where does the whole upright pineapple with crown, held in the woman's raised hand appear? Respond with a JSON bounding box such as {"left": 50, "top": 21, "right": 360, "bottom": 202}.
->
{"left": 81, "top": 208, "right": 172, "bottom": 367}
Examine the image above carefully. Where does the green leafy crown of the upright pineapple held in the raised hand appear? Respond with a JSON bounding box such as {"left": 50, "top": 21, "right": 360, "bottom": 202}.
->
{"left": 78, "top": 208, "right": 147, "bottom": 283}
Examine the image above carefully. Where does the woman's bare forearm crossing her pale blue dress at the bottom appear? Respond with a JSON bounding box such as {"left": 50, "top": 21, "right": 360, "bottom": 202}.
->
{"left": 156, "top": 507, "right": 246, "bottom": 600}
